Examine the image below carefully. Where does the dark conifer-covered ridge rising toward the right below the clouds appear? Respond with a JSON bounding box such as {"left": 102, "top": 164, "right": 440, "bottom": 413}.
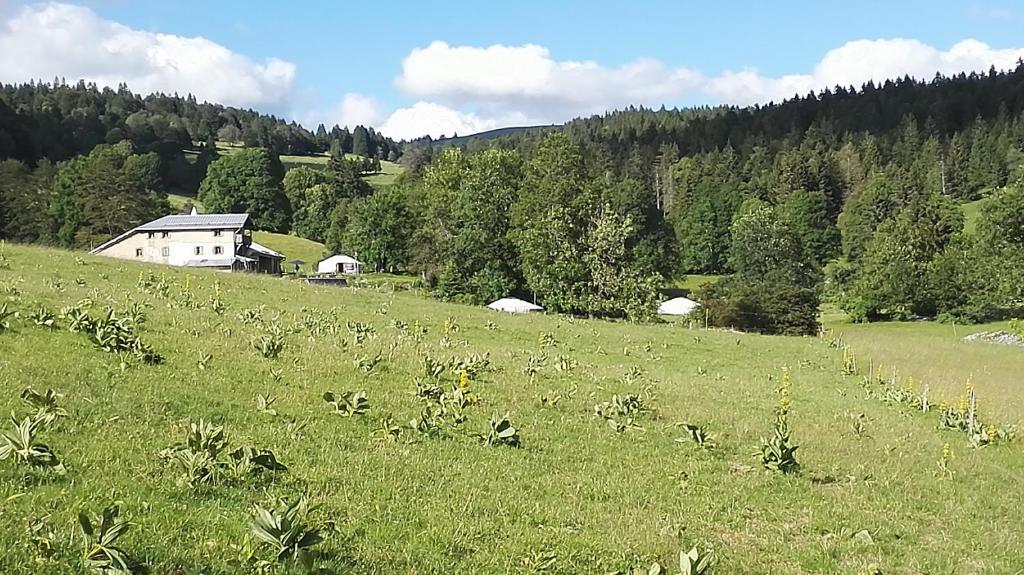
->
{"left": 458, "top": 65, "right": 1024, "bottom": 168}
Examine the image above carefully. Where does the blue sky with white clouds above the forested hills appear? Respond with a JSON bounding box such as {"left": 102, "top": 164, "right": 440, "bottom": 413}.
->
{"left": 0, "top": 0, "right": 1024, "bottom": 139}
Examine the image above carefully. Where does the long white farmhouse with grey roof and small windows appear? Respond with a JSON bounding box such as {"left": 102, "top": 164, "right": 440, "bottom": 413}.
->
{"left": 90, "top": 210, "right": 285, "bottom": 273}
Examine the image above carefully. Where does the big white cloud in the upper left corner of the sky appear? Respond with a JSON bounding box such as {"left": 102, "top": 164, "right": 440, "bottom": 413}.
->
{"left": 0, "top": 2, "right": 296, "bottom": 107}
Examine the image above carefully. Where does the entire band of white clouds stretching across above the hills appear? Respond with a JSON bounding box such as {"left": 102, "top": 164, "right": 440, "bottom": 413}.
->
{"left": 8, "top": 0, "right": 1024, "bottom": 138}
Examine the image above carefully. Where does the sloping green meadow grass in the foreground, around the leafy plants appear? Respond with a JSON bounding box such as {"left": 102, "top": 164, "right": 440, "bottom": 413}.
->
{"left": 0, "top": 246, "right": 1024, "bottom": 575}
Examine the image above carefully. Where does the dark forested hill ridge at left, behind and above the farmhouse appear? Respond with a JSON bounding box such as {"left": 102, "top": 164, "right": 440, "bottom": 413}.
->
{"left": 0, "top": 80, "right": 401, "bottom": 165}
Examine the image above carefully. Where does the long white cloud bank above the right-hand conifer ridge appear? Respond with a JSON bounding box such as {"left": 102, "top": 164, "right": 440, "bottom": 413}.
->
{"left": 383, "top": 38, "right": 1024, "bottom": 137}
